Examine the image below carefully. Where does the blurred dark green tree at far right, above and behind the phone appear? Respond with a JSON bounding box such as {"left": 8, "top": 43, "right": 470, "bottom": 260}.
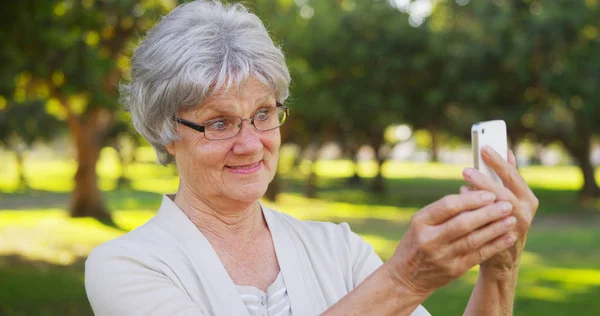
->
{"left": 428, "top": 0, "right": 600, "bottom": 198}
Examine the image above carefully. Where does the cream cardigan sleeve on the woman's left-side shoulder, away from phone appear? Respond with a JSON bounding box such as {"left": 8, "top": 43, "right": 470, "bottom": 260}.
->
{"left": 85, "top": 246, "right": 204, "bottom": 316}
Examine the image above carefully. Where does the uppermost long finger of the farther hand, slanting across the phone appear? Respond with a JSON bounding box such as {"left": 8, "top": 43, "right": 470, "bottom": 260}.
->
{"left": 481, "top": 146, "right": 533, "bottom": 198}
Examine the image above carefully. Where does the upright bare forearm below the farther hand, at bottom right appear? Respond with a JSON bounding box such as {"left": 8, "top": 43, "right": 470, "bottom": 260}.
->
{"left": 464, "top": 267, "right": 519, "bottom": 316}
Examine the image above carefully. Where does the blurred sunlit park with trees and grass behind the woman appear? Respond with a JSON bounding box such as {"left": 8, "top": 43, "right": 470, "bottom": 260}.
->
{"left": 0, "top": 0, "right": 600, "bottom": 315}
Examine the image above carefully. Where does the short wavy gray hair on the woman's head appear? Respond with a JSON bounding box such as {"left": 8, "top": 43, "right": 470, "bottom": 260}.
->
{"left": 120, "top": 0, "right": 290, "bottom": 165}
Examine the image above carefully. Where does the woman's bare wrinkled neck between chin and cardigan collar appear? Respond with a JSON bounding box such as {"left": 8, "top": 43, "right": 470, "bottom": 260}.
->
{"left": 174, "top": 187, "right": 266, "bottom": 243}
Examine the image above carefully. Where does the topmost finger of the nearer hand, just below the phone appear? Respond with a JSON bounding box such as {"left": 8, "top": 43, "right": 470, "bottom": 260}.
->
{"left": 413, "top": 190, "right": 496, "bottom": 225}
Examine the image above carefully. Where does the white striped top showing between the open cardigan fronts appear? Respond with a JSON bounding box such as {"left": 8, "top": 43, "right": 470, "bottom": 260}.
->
{"left": 237, "top": 273, "right": 292, "bottom": 316}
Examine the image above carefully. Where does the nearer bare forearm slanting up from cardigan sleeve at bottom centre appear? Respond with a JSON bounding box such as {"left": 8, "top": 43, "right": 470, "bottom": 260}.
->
{"left": 323, "top": 264, "right": 429, "bottom": 316}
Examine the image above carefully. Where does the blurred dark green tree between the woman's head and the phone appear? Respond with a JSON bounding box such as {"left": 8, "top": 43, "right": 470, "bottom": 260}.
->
{"left": 274, "top": 1, "right": 423, "bottom": 193}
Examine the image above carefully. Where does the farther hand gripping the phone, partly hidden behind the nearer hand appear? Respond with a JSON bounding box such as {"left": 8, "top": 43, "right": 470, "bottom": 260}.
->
{"left": 460, "top": 146, "right": 539, "bottom": 272}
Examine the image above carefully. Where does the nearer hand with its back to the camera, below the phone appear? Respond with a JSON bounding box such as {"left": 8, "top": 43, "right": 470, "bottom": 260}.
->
{"left": 385, "top": 190, "right": 516, "bottom": 296}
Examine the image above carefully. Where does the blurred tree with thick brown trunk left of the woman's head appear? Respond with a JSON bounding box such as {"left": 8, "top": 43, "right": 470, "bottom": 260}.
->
{"left": 0, "top": 0, "right": 176, "bottom": 219}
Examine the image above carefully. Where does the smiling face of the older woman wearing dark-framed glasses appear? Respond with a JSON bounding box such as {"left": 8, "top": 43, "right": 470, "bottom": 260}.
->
{"left": 167, "top": 78, "right": 281, "bottom": 203}
